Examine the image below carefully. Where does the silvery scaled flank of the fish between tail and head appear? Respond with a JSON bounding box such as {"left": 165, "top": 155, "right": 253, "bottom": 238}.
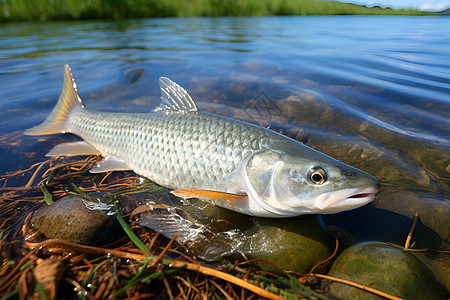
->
{"left": 67, "top": 109, "right": 270, "bottom": 189}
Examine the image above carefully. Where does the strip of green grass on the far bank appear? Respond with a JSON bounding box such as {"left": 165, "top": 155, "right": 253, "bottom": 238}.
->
{"left": 0, "top": 0, "right": 435, "bottom": 22}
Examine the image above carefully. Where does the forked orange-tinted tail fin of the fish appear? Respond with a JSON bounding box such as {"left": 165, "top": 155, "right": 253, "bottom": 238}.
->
{"left": 24, "top": 65, "right": 84, "bottom": 135}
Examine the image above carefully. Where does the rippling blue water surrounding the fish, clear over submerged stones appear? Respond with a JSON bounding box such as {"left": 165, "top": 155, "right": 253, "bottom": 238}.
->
{"left": 0, "top": 16, "right": 450, "bottom": 286}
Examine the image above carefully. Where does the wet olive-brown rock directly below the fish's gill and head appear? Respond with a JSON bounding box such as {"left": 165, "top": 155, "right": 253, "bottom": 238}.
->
{"left": 243, "top": 216, "right": 331, "bottom": 273}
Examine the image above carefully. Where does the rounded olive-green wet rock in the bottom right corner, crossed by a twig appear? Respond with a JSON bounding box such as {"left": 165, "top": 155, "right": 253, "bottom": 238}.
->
{"left": 328, "top": 242, "right": 448, "bottom": 299}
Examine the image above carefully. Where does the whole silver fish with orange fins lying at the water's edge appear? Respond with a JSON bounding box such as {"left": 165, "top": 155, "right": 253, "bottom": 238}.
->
{"left": 24, "top": 65, "right": 380, "bottom": 218}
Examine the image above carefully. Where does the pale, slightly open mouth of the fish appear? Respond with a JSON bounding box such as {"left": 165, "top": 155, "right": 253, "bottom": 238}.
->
{"left": 314, "top": 187, "right": 378, "bottom": 213}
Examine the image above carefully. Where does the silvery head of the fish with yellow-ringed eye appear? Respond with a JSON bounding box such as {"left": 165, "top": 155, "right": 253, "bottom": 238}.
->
{"left": 239, "top": 145, "right": 379, "bottom": 217}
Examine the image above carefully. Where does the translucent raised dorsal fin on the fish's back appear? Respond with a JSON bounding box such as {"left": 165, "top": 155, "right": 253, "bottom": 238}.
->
{"left": 154, "top": 77, "right": 198, "bottom": 114}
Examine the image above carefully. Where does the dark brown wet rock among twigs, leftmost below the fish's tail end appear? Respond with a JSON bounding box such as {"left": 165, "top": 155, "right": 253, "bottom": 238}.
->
{"left": 30, "top": 195, "right": 122, "bottom": 245}
